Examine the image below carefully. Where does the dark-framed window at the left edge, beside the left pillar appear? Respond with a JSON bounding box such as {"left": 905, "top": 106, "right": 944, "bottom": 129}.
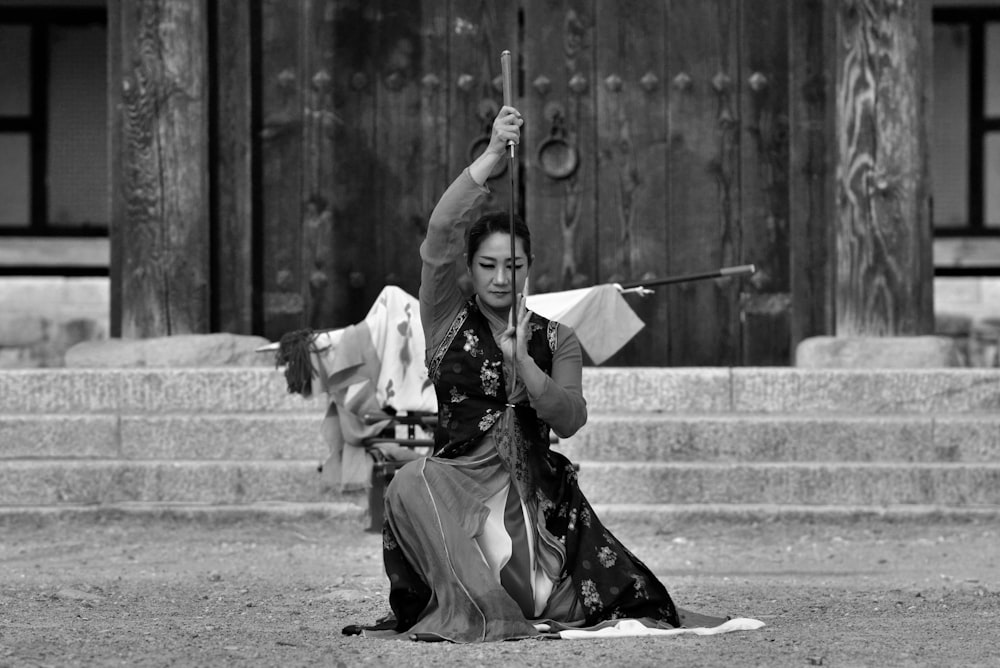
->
{"left": 0, "top": 2, "right": 110, "bottom": 274}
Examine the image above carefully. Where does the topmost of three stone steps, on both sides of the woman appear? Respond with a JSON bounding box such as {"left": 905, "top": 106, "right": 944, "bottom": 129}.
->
{"left": 0, "top": 367, "right": 1000, "bottom": 414}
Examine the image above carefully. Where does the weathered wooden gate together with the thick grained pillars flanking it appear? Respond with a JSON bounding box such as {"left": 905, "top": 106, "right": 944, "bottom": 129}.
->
{"left": 109, "top": 0, "right": 933, "bottom": 366}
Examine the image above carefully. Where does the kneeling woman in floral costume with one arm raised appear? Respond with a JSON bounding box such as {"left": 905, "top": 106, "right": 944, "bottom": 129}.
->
{"left": 356, "top": 106, "right": 724, "bottom": 642}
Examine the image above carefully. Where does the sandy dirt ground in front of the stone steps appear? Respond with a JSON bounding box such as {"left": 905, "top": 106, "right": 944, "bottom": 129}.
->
{"left": 0, "top": 506, "right": 1000, "bottom": 668}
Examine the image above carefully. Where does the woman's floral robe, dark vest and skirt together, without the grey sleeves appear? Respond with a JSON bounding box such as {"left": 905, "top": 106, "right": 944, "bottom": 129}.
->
{"left": 372, "top": 300, "right": 680, "bottom": 642}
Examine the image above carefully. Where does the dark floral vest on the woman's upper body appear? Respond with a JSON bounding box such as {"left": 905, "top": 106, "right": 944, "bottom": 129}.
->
{"left": 427, "top": 298, "right": 558, "bottom": 457}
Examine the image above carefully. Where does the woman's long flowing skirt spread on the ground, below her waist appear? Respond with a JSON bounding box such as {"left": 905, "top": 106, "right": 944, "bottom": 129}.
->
{"left": 369, "top": 449, "right": 725, "bottom": 642}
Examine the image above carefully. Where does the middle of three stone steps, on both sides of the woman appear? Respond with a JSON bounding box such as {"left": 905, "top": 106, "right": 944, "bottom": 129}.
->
{"left": 7, "top": 411, "right": 1000, "bottom": 463}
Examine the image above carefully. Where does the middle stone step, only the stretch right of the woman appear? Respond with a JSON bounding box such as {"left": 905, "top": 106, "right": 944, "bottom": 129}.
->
{"left": 557, "top": 413, "right": 1000, "bottom": 462}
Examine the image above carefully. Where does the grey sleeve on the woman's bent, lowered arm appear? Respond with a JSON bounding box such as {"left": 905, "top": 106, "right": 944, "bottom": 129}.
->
{"left": 528, "top": 324, "right": 587, "bottom": 438}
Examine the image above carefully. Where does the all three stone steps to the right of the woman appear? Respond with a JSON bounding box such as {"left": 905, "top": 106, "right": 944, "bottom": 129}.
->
{"left": 564, "top": 368, "right": 1000, "bottom": 521}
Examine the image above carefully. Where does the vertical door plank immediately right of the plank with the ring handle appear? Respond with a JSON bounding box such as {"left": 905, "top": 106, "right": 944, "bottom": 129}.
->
{"left": 594, "top": 0, "right": 671, "bottom": 366}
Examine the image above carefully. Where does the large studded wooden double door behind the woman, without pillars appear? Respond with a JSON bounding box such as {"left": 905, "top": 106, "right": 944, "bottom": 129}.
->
{"left": 260, "top": 0, "right": 792, "bottom": 366}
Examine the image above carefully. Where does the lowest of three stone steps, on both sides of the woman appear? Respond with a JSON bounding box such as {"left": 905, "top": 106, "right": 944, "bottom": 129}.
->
{"left": 0, "top": 460, "right": 1000, "bottom": 508}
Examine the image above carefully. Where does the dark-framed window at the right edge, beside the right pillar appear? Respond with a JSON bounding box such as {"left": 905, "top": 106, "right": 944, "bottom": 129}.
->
{"left": 931, "top": 5, "right": 1000, "bottom": 274}
